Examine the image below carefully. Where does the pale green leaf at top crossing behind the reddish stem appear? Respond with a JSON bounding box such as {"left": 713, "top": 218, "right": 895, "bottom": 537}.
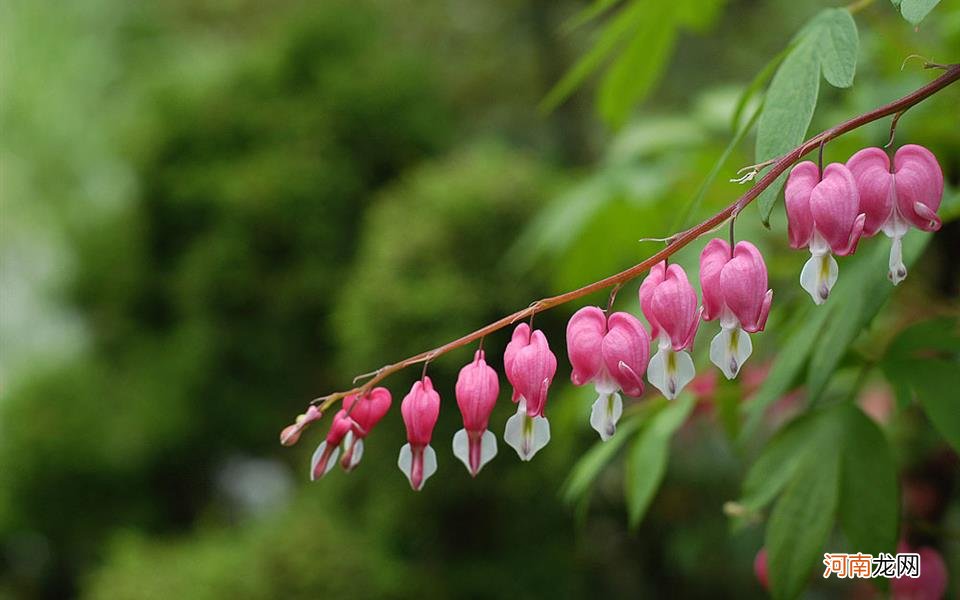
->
{"left": 756, "top": 36, "right": 820, "bottom": 225}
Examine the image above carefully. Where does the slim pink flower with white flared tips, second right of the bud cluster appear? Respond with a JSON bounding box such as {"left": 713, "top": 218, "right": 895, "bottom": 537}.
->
{"left": 453, "top": 350, "right": 500, "bottom": 477}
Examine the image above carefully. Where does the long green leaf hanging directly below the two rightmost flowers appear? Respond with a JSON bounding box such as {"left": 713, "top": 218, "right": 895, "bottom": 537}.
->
{"left": 807, "top": 232, "right": 931, "bottom": 402}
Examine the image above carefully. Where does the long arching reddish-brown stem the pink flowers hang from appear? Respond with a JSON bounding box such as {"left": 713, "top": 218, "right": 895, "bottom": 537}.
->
{"left": 311, "top": 64, "right": 960, "bottom": 412}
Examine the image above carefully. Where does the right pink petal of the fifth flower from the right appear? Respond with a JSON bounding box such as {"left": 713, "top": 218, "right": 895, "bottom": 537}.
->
{"left": 601, "top": 312, "right": 650, "bottom": 397}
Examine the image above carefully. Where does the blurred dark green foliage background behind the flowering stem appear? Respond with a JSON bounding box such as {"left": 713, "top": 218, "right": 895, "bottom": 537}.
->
{"left": 0, "top": 0, "right": 960, "bottom": 599}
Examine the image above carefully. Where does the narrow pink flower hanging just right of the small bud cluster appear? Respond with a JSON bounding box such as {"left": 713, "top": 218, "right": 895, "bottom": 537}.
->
{"left": 397, "top": 376, "right": 440, "bottom": 491}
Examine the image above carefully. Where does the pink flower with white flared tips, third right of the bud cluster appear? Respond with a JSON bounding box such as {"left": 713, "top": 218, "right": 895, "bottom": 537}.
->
{"left": 503, "top": 323, "right": 557, "bottom": 460}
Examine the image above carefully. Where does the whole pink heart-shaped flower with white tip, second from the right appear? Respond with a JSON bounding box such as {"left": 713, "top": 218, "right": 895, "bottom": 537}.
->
{"left": 784, "top": 161, "right": 866, "bottom": 304}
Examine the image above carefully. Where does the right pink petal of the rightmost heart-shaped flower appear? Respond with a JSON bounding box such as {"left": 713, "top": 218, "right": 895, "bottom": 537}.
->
{"left": 893, "top": 144, "right": 943, "bottom": 231}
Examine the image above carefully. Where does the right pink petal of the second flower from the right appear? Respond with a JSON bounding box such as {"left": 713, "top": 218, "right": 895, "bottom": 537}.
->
{"left": 810, "top": 163, "right": 860, "bottom": 254}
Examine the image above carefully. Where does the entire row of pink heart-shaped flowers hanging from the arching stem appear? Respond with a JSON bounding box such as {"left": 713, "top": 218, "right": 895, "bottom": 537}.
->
{"left": 281, "top": 145, "right": 943, "bottom": 490}
